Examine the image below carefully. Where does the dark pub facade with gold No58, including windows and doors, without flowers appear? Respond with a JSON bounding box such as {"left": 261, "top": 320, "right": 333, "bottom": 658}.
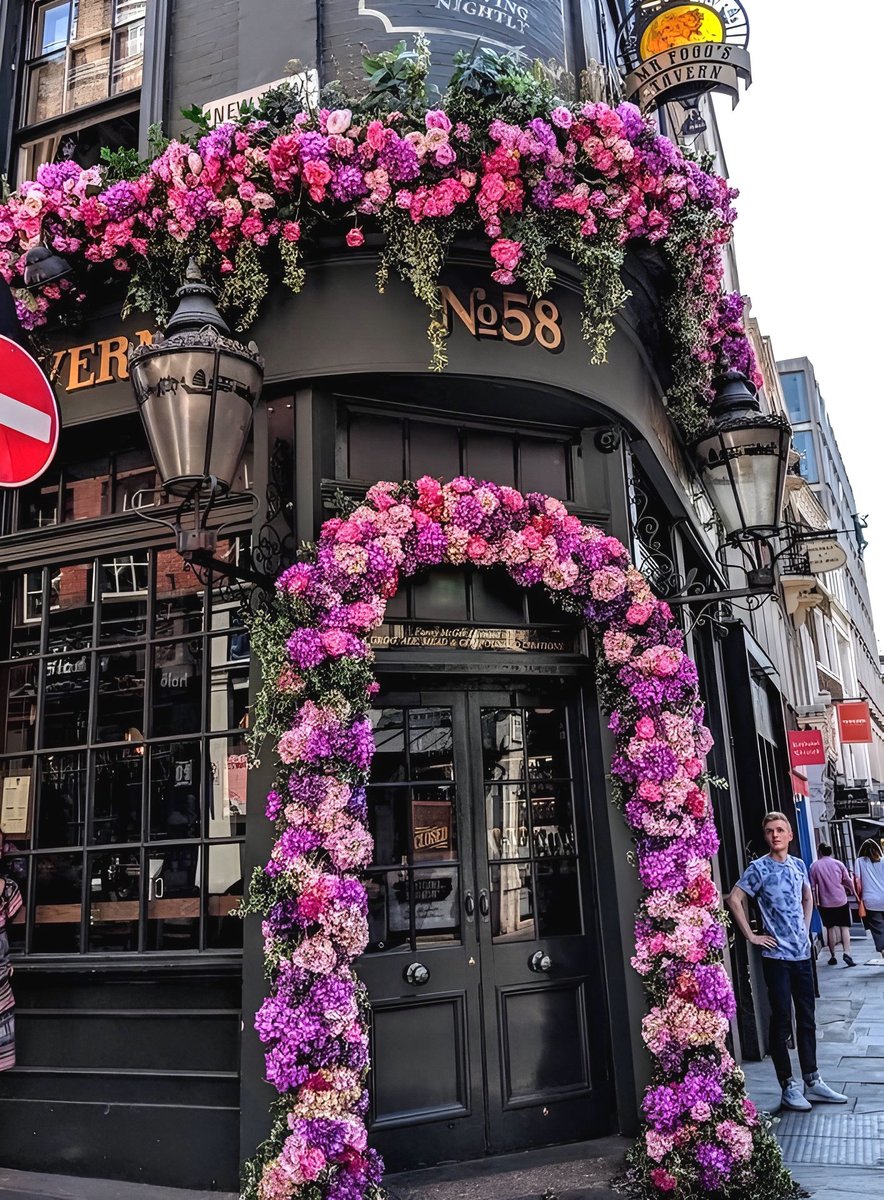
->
{"left": 0, "top": 0, "right": 791, "bottom": 1190}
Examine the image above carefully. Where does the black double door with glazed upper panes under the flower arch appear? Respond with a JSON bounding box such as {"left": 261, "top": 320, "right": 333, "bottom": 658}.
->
{"left": 359, "top": 689, "right": 611, "bottom": 1170}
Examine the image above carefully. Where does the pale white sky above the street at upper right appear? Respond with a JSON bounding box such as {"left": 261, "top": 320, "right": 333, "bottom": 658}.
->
{"left": 715, "top": 0, "right": 884, "bottom": 650}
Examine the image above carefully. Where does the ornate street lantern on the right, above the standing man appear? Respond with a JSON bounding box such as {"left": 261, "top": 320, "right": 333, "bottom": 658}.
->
{"left": 691, "top": 371, "right": 792, "bottom": 541}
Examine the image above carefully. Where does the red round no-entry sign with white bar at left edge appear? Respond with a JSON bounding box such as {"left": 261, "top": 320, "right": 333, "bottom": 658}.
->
{"left": 0, "top": 336, "right": 60, "bottom": 487}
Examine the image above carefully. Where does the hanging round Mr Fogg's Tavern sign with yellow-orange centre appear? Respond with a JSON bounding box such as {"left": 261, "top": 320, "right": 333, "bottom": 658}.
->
{"left": 617, "top": 0, "right": 752, "bottom": 119}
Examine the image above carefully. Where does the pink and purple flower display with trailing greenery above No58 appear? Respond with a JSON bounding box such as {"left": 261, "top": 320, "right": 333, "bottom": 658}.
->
{"left": 0, "top": 40, "right": 760, "bottom": 436}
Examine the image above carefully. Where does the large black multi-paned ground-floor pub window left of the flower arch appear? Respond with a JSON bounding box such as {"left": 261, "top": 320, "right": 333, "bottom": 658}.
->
{"left": 0, "top": 535, "right": 249, "bottom": 954}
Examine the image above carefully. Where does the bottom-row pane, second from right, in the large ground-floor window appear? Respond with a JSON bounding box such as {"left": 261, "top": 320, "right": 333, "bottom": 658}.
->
{"left": 146, "top": 846, "right": 202, "bottom": 952}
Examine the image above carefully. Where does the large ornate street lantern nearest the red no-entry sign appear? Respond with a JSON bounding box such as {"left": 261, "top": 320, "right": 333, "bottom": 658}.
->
{"left": 128, "top": 259, "right": 264, "bottom": 497}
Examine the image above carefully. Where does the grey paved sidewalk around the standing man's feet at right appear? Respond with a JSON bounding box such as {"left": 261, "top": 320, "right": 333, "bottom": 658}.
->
{"left": 742, "top": 930, "right": 884, "bottom": 1200}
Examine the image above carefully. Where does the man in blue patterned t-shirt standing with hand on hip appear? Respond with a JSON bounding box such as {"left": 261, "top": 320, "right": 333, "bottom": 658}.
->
{"left": 727, "top": 812, "right": 847, "bottom": 1112}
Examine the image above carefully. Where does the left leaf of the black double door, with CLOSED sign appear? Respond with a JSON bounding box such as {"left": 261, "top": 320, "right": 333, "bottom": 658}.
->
{"left": 357, "top": 692, "right": 486, "bottom": 1170}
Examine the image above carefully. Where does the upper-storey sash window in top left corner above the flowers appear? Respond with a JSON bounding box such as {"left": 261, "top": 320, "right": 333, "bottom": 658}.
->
{"left": 18, "top": 0, "right": 146, "bottom": 181}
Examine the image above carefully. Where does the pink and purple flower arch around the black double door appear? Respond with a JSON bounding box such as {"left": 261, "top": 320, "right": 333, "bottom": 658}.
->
{"left": 243, "top": 476, "right": 795, "bottom": 1200}
